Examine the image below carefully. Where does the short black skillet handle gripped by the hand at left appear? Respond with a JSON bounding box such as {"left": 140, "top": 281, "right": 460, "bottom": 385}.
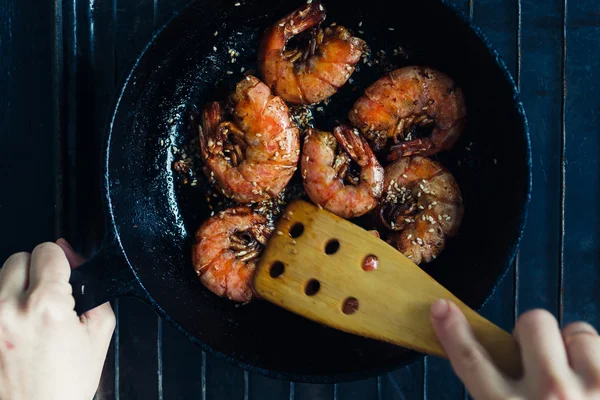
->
{"left": 69, "top": 241, "right": 142, "bottom": 315}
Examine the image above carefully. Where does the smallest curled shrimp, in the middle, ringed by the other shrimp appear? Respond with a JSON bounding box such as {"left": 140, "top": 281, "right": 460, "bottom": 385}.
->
{"left": 301, "top": 126, "right": 383, "bottom": 218}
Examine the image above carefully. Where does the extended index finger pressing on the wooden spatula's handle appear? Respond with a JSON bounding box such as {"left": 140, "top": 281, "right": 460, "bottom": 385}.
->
{"left": 431, "top": 300, "right": 509, "bottom": 399}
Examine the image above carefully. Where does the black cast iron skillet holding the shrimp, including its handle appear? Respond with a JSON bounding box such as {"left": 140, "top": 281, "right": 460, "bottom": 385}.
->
{"left": 72, "top": 0, "right": 531, "bottom": 382}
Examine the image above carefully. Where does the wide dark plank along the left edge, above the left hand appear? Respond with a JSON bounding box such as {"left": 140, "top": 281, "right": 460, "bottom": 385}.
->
{"left": 0, "top": 0, "right": 60, "bottom": 256}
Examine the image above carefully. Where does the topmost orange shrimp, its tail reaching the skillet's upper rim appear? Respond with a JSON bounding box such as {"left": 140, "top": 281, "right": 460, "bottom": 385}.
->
{"left": 258, "top": 1, "right": 365, "bottom": 104}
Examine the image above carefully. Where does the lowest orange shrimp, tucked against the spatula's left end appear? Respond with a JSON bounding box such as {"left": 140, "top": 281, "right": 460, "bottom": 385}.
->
{"left": 192, "top": 207, "right": 271, "bottom": 303}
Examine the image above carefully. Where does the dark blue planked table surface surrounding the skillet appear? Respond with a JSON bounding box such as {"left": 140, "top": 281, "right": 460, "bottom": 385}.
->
{"left": 0, "top": 0, "right": 600, "bottom": 400}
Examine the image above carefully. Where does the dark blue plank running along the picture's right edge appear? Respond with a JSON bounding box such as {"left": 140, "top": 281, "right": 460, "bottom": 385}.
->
{"left": 564, "top": 0, "right": 600, "bottom": 326}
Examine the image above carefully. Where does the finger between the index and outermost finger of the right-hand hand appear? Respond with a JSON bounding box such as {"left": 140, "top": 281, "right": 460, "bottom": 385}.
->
{"left": 515, "top": 310, "right": 572, "bottom": 390}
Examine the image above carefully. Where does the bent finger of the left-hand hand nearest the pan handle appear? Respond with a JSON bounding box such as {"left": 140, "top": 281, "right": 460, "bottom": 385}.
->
{"left": 29, "top": 243, "right": 71, "bottom": 291}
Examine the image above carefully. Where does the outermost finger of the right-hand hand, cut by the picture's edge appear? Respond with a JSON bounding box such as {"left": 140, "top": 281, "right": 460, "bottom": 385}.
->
{"left": 563, "top": 322, "right": 600, "bottom": 387}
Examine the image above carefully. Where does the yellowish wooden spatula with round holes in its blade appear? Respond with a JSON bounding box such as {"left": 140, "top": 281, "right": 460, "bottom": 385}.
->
{"left": 254, "top": 201, "right": 522, "bottom": 378}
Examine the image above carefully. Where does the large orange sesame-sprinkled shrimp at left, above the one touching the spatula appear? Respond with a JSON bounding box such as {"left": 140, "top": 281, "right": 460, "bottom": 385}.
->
{"left": 200, "top": 76, "right": 300, "bottom": 203}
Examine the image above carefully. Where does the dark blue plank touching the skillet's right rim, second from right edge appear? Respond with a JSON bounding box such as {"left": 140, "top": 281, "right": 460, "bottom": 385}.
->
{"left": 518, "top": 0, "right": 562, "bottom": 315}
